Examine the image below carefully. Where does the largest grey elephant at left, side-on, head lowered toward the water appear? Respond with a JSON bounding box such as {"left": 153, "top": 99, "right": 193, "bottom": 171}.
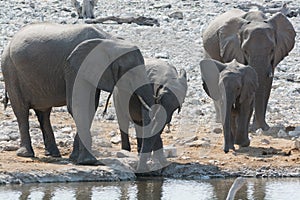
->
{"left": 1, "top": 23, "right": 154, "bottom": 164}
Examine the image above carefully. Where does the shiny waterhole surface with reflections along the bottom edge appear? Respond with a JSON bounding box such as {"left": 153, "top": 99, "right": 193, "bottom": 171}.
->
{"left": 0, "top": 178, "right": 300, "bottom": 200}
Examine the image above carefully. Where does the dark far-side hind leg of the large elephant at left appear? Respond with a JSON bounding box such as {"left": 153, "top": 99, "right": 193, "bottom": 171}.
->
{"left": 34, "top": 108, "right": 61, "bottom": 157}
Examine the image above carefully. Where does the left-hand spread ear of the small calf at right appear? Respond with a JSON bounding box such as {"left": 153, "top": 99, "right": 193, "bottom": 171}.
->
{"left": 200, "top": 59, "right": 226, "bottom": 100}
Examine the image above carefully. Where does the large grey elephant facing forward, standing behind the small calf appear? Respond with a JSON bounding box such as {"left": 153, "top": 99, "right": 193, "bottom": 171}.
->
{"left": 202, "top": 9, "right": 296, "bottom": 130}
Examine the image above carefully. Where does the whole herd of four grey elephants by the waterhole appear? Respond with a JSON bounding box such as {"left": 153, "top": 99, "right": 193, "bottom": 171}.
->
{"left": 1, "top": 10, "right": 296, "bottom": 172}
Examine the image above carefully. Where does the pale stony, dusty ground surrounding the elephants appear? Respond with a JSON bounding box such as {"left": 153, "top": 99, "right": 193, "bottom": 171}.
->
{"left": 0, "top": 0, "right": 300, "bottom": 182}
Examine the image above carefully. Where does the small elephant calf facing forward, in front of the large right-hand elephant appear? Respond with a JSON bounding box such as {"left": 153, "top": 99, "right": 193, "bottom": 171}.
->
{"left": 200, "top": 59, "right": 258, "bottom": 153}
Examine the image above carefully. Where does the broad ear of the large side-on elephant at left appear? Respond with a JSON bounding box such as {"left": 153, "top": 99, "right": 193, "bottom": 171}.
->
{"left": 67, "top": 39, "right": 137, "bottom": 92}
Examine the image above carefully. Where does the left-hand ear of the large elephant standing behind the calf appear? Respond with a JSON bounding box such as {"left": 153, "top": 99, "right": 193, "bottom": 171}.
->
{"left": 218, "top": 17, "right": 248, "bottom": 63}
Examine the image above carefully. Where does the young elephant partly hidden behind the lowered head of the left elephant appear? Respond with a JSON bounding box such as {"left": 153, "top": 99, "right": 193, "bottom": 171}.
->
{"left": 113, "top": 58, "right": 187, "bottom": 165}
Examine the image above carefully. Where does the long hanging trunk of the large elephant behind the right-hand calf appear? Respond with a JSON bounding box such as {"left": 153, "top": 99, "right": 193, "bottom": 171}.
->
{"left": 250, "top": 56, "right": 273, "bottom": 130}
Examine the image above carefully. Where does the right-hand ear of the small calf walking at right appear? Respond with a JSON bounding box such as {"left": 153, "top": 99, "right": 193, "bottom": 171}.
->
{"left": 239, "top": 66, "right": 258, "bottom": 103}
